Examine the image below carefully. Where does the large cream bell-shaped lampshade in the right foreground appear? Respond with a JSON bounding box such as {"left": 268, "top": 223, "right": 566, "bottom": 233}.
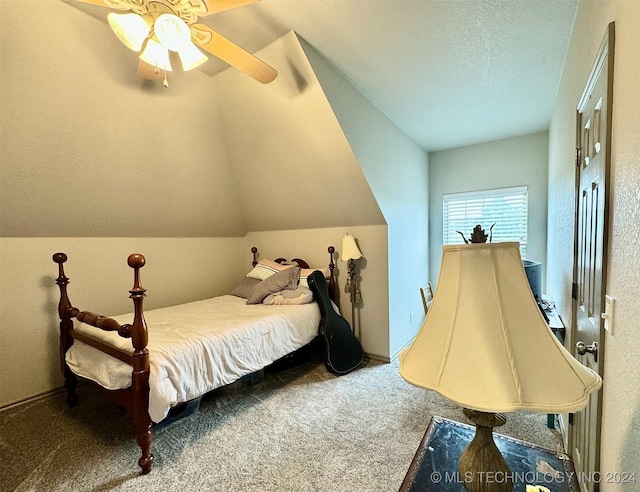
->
{"left": 400, "top": 242, "right": 602, "bottom": 413}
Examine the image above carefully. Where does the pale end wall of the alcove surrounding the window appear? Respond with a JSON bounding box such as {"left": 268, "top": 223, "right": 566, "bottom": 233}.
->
{"left": 429, "top": 132, "right": 548, "bottom": 284}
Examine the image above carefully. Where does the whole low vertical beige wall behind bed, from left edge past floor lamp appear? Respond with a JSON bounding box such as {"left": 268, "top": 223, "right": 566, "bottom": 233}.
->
{"left": 0, "top": 226, "right": 388, "bottom": 407}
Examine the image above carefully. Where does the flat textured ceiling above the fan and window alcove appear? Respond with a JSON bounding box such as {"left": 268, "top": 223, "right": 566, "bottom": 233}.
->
{"left": 64, "top": 0, "right": 577, "bottom": 151}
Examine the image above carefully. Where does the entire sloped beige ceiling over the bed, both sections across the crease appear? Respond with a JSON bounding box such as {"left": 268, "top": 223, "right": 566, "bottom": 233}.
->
{"left": 0, "top": 2, "right": 384, "bottom": 237}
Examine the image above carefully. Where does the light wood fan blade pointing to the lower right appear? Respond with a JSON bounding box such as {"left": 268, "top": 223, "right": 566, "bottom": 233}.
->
{"left": 191, "top": 24, "right": 278, "bottom": 84}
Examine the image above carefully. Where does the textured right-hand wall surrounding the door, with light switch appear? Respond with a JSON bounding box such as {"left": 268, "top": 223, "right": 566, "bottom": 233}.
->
{"left": 547, "top": 0, "right": 640, "bottom": 484}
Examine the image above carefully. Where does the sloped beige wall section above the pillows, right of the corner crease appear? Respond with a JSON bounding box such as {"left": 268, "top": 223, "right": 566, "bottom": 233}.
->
{"left": 216, "top": 31, "right": 385, "bottom": 231}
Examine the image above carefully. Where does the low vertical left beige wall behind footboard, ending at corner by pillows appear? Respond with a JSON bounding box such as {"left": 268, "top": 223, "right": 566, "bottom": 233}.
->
{"left": 0, "top": 238, "right": 246, "bottom": 406}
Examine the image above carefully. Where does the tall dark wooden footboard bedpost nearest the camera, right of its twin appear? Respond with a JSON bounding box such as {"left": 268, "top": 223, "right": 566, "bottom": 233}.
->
{"left": 127, "top": 254, "right": 153, "bottom": 474}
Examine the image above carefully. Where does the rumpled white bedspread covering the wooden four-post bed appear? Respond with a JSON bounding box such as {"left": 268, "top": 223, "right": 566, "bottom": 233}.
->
{"left": 66, "top": 295, "right": 320, "bottom": 422}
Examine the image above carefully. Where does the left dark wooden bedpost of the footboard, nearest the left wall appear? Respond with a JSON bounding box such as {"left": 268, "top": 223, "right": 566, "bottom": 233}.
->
{"left": 53, "top": 253, "right": 78, "bottom": 407}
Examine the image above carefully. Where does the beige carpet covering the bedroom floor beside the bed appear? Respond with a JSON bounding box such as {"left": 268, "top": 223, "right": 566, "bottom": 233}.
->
{"left": 0, "top": 361, "right": 561, "bottom": 492}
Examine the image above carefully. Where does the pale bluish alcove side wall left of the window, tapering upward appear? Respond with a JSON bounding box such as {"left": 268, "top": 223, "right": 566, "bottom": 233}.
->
{"left": 301, "top": 40, "right": 432, "bottom": 358}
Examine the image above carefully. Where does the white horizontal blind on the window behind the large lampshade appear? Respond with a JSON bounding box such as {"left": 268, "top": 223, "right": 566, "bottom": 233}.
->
{"left": 442, "top": 186, "right": 528, "bottom": 258}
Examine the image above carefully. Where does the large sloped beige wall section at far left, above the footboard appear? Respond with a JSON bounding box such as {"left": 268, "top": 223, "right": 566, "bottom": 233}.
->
{"left": 0, "top": 0, "right": 247, "bottom": 237}
